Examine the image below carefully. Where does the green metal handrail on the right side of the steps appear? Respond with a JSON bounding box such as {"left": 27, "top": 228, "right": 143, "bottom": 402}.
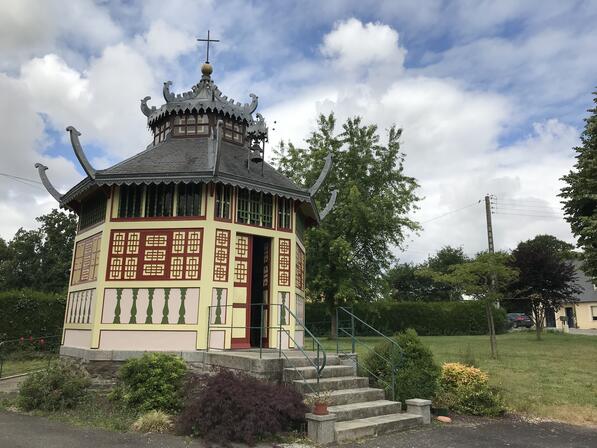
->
{"left": 336, "top": 306, "right": 402, "bottom": 400}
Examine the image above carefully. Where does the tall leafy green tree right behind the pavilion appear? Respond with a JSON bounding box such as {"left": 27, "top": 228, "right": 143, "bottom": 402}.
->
{"left": 276, "top": 115, "right": 418, "bottom": 336}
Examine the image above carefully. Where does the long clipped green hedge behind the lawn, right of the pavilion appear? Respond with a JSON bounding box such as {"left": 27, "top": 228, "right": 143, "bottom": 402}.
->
{"left": 305, "top": 301, "right": 507, "bottom": 336}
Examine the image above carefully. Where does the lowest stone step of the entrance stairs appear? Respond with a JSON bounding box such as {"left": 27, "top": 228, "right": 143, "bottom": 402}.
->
{"left": 336, "top": 413, "right": 423, "bottom": 442}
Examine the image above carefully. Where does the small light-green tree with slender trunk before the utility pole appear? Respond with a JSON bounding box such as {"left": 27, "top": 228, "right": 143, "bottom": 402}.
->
{"left": 428, "top": 252, "right": 518, "bottom": 358}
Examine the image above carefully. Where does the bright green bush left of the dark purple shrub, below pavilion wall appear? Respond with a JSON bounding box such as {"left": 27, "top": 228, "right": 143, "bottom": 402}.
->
{"left": 112, "top": 353, "right": 187, "bottom": 412}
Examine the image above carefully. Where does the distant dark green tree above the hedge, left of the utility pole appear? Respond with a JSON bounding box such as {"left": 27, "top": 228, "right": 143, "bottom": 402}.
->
{"left": 387, "top": 246, "right": 469, "bottom": 302}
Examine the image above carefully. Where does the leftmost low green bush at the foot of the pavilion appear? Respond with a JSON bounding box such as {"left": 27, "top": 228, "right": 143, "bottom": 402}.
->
{"left": 17, "top": 361, "right": 91, "bottom": 411}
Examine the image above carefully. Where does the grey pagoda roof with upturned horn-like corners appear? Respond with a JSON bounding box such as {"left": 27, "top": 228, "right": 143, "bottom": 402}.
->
{"left": 36, "top": 63, "right": 337, "bottom": 221}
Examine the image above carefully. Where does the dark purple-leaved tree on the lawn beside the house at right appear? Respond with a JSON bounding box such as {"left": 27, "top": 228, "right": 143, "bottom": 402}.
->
{"left": 510, "top": 235, "right": 581, "bottom": 339}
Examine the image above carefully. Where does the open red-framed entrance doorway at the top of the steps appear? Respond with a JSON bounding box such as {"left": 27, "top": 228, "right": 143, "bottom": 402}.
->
{"left": 232, "top": 234, "right": 271, "bottom": 348}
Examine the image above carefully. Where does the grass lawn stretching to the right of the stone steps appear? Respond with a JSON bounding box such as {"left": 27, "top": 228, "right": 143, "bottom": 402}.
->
{"left": 314, "top": 332, "right": 597, "bottom": 425}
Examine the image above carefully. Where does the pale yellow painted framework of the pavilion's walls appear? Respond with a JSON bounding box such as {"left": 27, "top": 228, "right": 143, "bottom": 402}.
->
{"left": 63, "top": 184, "right": 304, "bottom": 349}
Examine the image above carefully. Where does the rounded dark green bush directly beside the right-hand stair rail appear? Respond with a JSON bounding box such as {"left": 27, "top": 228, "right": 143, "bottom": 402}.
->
{"left": 361, "top": 329, "right": 440, "bottom": 403}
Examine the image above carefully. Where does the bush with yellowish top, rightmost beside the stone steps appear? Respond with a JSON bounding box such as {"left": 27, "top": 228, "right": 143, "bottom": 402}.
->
{"left": 434, "top": 362, "right": 505, "bottom": 416}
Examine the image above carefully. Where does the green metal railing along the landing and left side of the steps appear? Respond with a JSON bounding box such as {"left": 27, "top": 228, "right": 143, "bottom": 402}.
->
{"left": 206, "top": 303, "right": 327, "bottom": 392}
